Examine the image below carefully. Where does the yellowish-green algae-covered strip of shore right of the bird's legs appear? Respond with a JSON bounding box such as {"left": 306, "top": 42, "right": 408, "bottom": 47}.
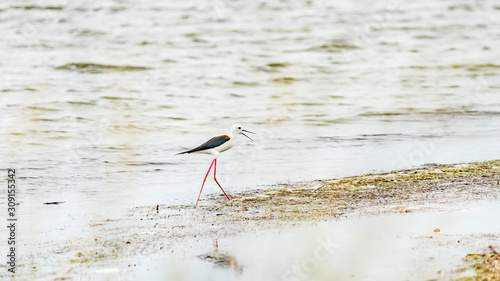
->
{"left": 217, "top": 160, "right": 500, "bottom": 221}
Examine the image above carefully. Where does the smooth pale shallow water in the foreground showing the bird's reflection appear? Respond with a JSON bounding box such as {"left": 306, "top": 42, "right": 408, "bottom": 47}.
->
{"left": 95, "top": 202, "right": 500, "bottom": 281}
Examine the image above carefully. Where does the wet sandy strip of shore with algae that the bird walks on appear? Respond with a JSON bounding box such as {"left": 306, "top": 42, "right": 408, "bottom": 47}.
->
{"left": 7, "top": 160, "right": 500, "bottom": 280}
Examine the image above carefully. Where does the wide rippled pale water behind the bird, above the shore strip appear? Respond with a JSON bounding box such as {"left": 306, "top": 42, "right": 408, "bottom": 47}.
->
{"left": 0, "top": 0, "right": 500, "bottom": 272}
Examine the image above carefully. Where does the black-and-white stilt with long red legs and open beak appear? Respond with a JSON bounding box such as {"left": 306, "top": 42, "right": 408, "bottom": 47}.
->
{"left": 177, "top": 124, "right": 255, "bottom": 206}
